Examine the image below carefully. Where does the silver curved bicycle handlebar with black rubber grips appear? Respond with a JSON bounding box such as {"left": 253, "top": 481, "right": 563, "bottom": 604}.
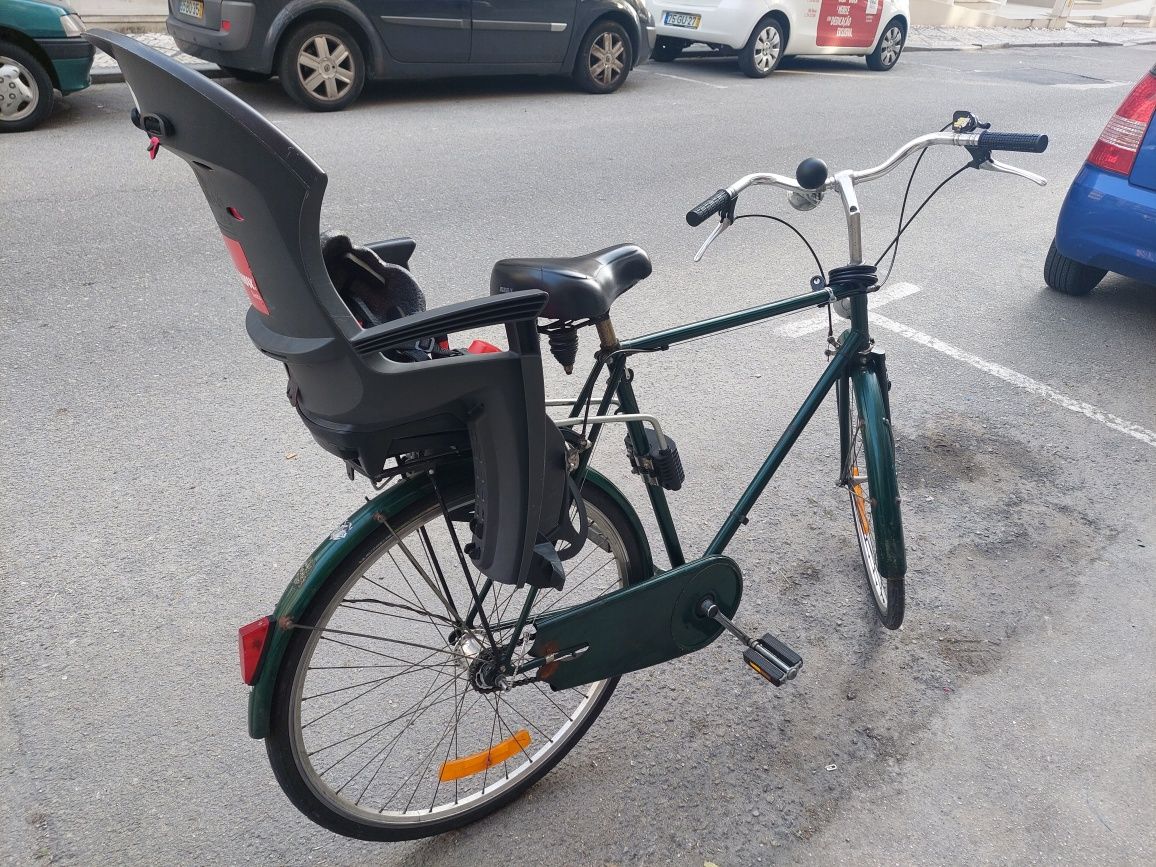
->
{"left": 687, "top": 131, "right": 1047, "bottom": 225}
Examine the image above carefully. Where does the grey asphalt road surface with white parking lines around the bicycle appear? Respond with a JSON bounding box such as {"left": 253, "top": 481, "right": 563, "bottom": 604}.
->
{"left": 0, "top": 47, "right": 1156, "bottom": 867}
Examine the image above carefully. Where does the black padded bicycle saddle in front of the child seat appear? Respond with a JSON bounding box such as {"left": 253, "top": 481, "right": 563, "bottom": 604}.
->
{"left": 490, "top": 244, "right": 652, "bottom": 320}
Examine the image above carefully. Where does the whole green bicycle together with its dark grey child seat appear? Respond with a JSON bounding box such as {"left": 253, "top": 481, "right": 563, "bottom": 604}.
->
{"left": 86, "top": 30, "right": 1047, "bottom": 840}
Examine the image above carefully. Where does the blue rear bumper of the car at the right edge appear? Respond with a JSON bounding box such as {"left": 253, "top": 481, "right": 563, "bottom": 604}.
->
{"left": 1055, "top": 165, "right": 1156, "bottom": 283}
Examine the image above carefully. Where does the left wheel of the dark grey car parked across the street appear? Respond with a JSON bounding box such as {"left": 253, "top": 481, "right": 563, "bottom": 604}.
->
{"left": 277, "top": 21, "right": 365, "bottom": 111}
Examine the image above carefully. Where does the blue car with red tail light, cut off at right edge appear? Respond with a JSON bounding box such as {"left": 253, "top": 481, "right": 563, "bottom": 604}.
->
{"left": 1044, "top": 66, "right": 1156, "bottom": 295}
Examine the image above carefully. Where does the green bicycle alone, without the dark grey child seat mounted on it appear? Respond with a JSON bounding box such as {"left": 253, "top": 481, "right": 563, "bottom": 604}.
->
{"left": 243, "top": 119, "right": 1047, "bottom": 840}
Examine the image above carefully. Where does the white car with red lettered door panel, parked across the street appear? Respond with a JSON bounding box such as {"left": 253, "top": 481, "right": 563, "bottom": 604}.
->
{"left": 646, "top": 0, "right": 910, "bottom": 79}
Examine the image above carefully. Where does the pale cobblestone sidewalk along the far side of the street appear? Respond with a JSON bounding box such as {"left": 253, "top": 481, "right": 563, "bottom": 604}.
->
{"left": 92, "top": 25, "right": 1156, "bottom": 84}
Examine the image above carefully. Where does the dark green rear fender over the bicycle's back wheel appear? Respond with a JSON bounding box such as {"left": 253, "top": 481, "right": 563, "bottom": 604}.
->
{"left": 249, "top": 469, "right": 654, "bottom": 739}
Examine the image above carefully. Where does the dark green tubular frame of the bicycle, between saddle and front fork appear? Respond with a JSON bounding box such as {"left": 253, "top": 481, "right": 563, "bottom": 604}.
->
{"left": 570, "top": 287, "right": 872, "bottom": 568}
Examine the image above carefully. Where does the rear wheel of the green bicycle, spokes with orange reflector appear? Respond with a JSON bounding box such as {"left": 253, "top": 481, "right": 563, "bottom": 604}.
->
{"left": 266, "top": 484, "right": 647, "bottom": 840}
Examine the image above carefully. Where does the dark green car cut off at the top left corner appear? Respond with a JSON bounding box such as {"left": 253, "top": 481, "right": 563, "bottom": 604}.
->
{"left": 0, "top": 0, "right": 92, "bottom": 133}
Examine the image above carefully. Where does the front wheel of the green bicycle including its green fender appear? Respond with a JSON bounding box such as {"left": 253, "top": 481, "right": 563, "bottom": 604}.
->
{"left": 839, "top": 369, "right": 907, "bottom": 629}
